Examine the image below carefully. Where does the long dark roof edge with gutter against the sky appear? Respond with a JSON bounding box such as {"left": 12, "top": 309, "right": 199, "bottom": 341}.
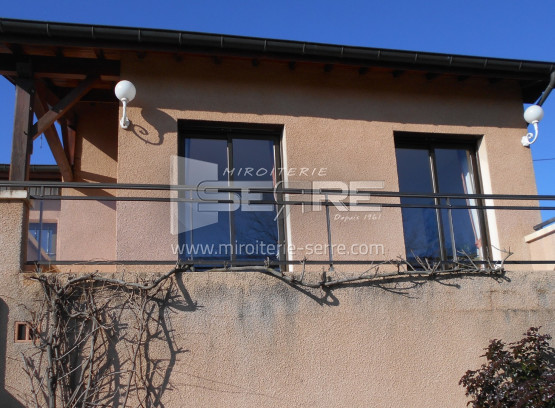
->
{"left": 0, "top": 18, "right": 555, "bottom": 81}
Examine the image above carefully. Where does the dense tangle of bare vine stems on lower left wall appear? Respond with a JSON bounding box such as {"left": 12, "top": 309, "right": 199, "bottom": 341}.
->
{"left": 22, "top": 268, "right": 184, "bottom": 408}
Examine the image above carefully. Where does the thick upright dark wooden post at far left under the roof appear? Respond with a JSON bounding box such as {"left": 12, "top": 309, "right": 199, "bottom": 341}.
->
{"left": 8, "top": 84, "right": 34, "bottom": 181}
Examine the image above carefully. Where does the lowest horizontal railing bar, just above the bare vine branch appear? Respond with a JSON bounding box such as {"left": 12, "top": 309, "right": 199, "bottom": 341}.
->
{"left": 26, "top": 259, "right": 555, "bottom": 267}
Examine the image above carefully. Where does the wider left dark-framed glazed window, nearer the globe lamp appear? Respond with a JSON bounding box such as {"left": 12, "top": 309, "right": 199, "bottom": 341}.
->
{"left": 179, "top": 121, "right": 283, "bottom": 261}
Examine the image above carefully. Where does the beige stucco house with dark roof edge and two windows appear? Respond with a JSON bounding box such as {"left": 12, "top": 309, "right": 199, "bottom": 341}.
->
{"left": 0, "top": 19, "right": 555, "bottom": 407}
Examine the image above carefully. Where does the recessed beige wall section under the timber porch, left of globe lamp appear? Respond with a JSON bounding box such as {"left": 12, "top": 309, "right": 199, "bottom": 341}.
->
{"left": 57, "top": 102, "right": 118, "bottom": 264}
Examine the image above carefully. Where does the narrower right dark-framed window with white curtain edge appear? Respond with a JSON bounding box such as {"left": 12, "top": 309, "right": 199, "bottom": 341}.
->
{"left": 396, "top": 135, "right": 486, "bottom": 263}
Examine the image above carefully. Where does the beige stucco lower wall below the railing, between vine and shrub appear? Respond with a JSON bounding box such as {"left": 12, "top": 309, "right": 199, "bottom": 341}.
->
{"left": 153, "top": 272, "right": 555, "bottom": 408}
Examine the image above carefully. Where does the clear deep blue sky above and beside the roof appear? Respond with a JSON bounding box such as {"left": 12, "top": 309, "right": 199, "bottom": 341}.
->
{"left": 0, "top": 0, "right": 555, "bottom": 219}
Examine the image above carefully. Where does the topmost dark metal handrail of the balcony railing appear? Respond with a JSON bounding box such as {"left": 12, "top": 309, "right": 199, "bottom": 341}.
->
{"left": 0, "top": 181, "right": 555, "bottom": 200}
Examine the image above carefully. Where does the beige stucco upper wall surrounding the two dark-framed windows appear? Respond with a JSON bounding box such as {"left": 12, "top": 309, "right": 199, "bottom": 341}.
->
{"left": 117, "top": 54, "right": 540, "bottom": 270}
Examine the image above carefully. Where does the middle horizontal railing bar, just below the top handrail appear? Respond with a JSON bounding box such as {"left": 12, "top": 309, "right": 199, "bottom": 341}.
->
{"left": 25, "top": 195, "right": 555, "bottom": 211}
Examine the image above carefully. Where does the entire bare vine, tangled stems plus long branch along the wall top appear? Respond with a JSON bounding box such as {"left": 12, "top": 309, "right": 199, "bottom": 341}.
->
{"left": 22, "top": 251, "right": 511, "bottom": 408}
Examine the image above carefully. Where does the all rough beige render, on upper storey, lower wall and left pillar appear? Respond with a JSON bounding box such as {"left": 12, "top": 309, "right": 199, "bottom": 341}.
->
{"left": 0, "top": 55, "right": 555, "bottom": 407}
